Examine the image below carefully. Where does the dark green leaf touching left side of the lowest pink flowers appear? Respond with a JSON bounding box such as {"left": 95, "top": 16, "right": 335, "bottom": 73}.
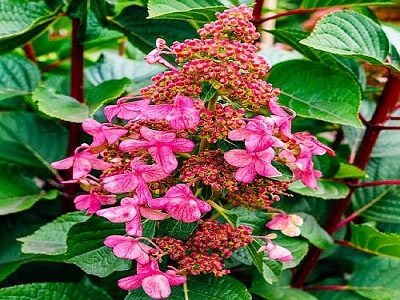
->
{"left": 65, "top": 216, "right": 131, "bottom": 277}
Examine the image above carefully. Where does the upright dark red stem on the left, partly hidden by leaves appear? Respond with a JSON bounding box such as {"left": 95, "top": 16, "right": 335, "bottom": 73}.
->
{"left": 63, "top": 19, "right": 84, "bottom": 212}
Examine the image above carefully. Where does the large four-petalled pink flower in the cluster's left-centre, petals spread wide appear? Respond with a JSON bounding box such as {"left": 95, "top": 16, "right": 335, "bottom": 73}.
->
{"left": 119, "top": 126, "right": 195, "bottom": 174}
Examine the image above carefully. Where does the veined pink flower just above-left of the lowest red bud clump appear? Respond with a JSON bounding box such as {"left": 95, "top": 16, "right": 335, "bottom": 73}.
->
{"left": 148, "top": 184, "right": 211, "bottom": 223}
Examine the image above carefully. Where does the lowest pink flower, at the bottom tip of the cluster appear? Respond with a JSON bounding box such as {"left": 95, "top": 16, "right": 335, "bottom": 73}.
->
{"left": 118, "top": 260, "right": 186, "bottom": 299}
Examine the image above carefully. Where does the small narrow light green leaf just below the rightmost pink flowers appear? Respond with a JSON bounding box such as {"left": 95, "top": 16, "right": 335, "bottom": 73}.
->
{"left": 289, "top": 180, "right": 349, "bottom": 200}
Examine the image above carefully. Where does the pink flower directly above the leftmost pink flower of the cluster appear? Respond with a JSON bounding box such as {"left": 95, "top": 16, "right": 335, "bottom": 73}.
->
{"left": 82, "top": 119, "right": 128, "bottom": 147}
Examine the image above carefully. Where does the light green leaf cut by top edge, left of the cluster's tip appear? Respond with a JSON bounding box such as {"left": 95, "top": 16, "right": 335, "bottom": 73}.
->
{"left": 148, "top": 0, "right": 226, "bottom": 23}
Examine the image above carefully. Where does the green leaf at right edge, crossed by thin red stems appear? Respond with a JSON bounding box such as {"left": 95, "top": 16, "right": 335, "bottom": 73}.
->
{"left": 352, "top": 156, "right": 400, "bottom": 223}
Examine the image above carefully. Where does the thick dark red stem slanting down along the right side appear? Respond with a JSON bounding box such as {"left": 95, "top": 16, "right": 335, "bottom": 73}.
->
{"left": 292, "top": 72, "right": 400, "bottom": 288}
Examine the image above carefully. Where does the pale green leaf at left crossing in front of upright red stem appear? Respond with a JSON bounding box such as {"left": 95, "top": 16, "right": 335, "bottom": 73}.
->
{"left": 32, "top": 87, "right": 89, "bottom": 123}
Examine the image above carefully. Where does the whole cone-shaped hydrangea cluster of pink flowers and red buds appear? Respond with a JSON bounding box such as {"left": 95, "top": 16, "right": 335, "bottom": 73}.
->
{"left": 52, "top": 5, "right": 333, "bottom": 299}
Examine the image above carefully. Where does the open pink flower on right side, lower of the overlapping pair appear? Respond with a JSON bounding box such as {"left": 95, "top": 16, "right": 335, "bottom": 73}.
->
{"left": 224, "top": 148, "right": 282, "bottom": 183}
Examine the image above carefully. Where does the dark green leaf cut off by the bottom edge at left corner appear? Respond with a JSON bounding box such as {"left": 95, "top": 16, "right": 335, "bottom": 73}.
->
{"left": 0, "top": 282, "right": 113, "bottom": 300}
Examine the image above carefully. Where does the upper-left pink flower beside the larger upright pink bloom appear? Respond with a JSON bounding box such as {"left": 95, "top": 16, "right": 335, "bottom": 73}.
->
{"left": 104, "top": 97, "right": 150, "bottom": 122}
